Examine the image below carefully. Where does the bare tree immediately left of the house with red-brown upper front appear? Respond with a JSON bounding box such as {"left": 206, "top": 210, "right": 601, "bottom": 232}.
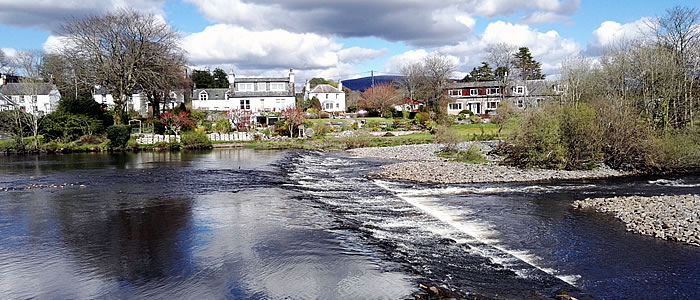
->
{"left": 423, "top": 54, "right": 455, "bottom": 106}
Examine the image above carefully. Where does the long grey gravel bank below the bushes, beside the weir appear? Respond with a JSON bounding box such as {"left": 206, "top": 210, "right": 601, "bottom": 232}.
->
{"left": 348, "top": 141, "right": 630, "bottom": 184}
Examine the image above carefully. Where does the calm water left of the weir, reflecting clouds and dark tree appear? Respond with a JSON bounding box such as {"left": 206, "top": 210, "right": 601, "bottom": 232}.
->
{"left": 0, "top": 149, "right": 412, "bottom": 299}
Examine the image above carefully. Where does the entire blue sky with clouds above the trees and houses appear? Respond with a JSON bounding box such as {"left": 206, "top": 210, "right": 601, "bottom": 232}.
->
{"left": 0, "top": 0, "right": 700, "bottom": 82}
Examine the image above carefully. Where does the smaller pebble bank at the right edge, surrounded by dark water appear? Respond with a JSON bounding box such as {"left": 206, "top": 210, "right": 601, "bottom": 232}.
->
{"left": 572, "top": 195, "right": 700, "bottom": 246}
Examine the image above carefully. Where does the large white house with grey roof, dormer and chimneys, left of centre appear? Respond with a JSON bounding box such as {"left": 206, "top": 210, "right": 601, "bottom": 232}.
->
{"left": 192, "top": 69, "right": 296, "bottom": 117}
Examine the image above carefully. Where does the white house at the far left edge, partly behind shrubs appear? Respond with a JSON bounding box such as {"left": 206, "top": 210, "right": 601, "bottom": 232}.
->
{"left": 0, "top": 80, "right": 61, "bottom": 115}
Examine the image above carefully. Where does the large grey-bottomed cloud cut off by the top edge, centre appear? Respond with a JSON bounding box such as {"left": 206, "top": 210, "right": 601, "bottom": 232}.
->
{"left": 186, "top": 0, "right": 580, "bottom": 46}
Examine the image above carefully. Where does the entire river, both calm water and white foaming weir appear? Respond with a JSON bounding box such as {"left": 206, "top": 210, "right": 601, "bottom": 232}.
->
{"left": 0, "top": 149, "right": 700, "bottom": 299}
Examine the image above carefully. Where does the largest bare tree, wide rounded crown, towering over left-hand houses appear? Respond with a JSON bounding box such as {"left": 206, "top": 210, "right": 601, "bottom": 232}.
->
{"left": 61, "top": 10, "right": 185, "bottom": 124}
